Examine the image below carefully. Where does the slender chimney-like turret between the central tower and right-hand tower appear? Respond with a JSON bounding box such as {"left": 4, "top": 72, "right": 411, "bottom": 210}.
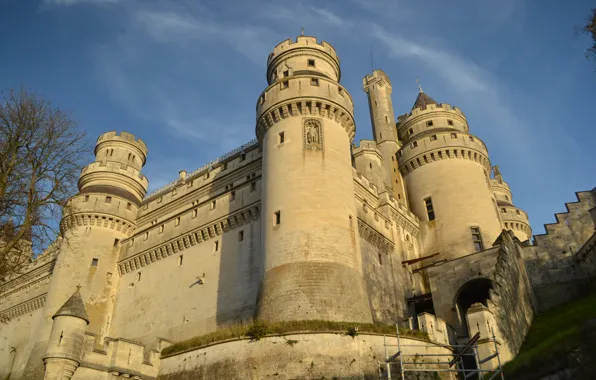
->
{"left": 362, "top": 70, "right": 407, "bottom": 204}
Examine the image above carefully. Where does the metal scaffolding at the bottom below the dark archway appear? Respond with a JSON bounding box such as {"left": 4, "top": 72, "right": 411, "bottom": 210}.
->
{"left": 383, "top": 325, "right": 505, "bottom": 380}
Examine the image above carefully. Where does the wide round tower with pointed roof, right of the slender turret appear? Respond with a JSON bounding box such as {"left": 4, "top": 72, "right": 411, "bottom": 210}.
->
{"left": 397, "top": 90, "right": 501, "bottom": 259}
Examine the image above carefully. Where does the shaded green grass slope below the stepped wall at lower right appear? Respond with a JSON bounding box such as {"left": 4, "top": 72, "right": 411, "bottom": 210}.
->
{"left": 504, "top": 292, "right": 596, "bottom": 376}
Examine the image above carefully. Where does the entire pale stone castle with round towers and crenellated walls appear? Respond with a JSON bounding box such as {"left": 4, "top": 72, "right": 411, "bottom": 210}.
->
{"left": 0, "top": 36, "right": 596, "bottom": 380}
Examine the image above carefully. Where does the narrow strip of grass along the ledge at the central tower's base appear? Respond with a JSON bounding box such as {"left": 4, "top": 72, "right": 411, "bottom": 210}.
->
{"left": 161, "top": 320, "right": 428, "bottom": 356}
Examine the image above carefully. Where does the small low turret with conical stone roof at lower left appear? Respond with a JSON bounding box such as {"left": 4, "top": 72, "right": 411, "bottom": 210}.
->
{"left": 43, "top": 288, "right": 89, "bottom": 380}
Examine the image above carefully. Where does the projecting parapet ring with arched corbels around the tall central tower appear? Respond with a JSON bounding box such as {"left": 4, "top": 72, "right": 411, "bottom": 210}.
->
{"left": 256, "top": 75, "right": 356, "bottom": 141}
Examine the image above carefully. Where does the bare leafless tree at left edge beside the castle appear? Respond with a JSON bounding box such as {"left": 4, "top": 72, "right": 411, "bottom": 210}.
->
{"left": 0, "top": 88, "right": 88, "bottom": 279}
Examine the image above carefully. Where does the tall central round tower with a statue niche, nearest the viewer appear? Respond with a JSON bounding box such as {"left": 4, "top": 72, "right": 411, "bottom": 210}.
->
{"left": 256, "top": 36, "right": 371, "bottom": 322}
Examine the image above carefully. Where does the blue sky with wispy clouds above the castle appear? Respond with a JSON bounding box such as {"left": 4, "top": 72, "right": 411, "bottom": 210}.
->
{"left": 0, "top": 0, "right": 596, "bottom": 233}
